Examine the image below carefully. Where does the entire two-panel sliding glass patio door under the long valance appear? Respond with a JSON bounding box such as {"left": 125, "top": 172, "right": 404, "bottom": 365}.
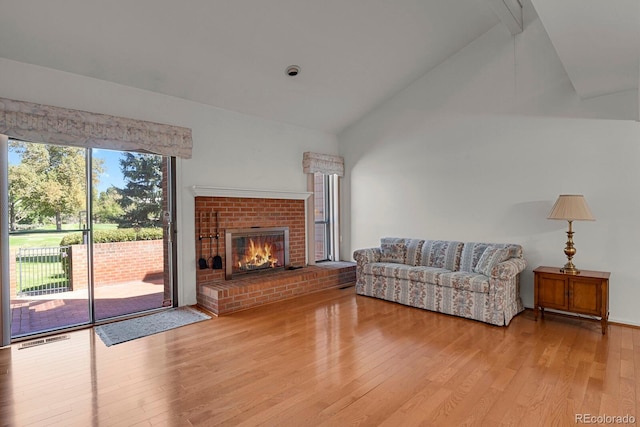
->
{"left": 2, "top": 140, "right": 174, "bottom": 339}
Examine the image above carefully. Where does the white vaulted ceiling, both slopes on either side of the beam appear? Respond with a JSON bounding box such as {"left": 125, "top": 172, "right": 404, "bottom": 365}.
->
{"left": 0, "top": 0, "right": 640, "bottom": 133}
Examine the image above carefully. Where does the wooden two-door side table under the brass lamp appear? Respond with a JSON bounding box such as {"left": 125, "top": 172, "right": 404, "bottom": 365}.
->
{"left": 533, "top": 267, "right": 611, "bottom": 335}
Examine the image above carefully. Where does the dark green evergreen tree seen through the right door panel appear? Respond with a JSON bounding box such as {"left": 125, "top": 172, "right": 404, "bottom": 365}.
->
{"left": 118, "top": 153, "right": 162, "bottom": 227}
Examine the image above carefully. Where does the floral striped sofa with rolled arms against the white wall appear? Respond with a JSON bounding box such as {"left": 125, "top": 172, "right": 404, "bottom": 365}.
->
{"left": 353, "top": 237, "right": 526, "bottom": 326}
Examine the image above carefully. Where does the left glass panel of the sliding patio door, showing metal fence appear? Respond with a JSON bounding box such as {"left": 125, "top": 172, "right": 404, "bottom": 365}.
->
{"left": 8, "top": 140, "right": 91, "bottom": 338}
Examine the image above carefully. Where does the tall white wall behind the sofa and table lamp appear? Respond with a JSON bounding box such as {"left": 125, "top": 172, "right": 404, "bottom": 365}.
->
{"left": 339, "top": 10, "right": 640, "bottom": 325}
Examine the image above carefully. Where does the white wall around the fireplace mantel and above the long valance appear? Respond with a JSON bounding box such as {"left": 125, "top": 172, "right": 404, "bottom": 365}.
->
{"left": 0, "top": 58, "right": 338, "bottom": 305}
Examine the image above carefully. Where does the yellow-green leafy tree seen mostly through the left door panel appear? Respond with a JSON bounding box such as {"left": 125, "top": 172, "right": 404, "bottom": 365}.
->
{"left": 9, "top": 141, "right": 102, "bottom": 230}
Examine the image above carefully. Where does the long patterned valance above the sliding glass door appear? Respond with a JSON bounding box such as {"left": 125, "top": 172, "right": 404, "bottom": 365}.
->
{"left": 0, "top": 98, "right": 193, "bottom": 159}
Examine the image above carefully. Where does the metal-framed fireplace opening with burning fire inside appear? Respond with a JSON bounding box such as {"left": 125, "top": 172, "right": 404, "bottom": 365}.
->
{"left": 225, "top": 227, "right": 289, "bottom": 280}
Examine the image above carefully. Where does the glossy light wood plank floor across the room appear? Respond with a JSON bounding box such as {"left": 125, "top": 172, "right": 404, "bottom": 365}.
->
{"left": 0, "top": 287, "right": 640, "bottom": 427}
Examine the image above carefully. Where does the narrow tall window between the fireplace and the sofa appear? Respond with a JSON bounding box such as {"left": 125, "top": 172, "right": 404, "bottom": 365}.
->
{"left": 314, "top": 172, "right": 338, "bottom": 262}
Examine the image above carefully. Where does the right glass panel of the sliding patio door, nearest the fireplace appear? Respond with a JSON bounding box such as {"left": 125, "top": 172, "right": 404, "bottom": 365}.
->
{"left": 91, "top": 150, "right": 172, "bottom": 320}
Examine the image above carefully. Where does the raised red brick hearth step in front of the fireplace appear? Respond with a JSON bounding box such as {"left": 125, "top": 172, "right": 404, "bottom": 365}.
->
{"left": 197, "top": 261, "right": 356, "bottom": 315}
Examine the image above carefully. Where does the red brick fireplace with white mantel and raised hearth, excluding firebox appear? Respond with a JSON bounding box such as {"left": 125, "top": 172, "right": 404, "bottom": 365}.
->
{"left": 194, "top": 187, "right": 355, "bottom": 315}
